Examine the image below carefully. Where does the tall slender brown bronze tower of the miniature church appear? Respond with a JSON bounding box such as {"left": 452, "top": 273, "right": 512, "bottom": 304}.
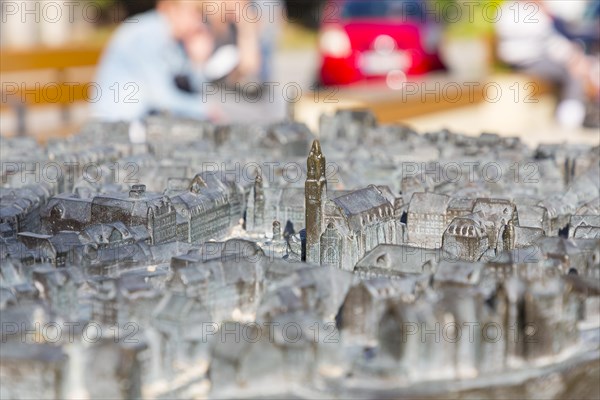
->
{"left": 304, "top": 140, "right": 327, "bottom": 264}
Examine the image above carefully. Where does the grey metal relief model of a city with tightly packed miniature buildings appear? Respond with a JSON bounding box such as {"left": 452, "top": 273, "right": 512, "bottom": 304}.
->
{"left": 0, "top": 110, "right": 600, "bottom": 399}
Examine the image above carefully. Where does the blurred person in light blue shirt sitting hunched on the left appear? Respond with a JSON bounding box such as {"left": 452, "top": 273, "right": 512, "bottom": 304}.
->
{"left": 92, "top": 0, "right": 218, "bottom": 120}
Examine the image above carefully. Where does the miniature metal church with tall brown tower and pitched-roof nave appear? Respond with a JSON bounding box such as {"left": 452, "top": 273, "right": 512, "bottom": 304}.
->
{"left": 305, "top": 140, "right": 402, "bottom": 271}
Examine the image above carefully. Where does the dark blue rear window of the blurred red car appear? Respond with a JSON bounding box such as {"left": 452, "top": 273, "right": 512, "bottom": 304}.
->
{"left": 342, "top": 0, "right": 425, "bottom": 20}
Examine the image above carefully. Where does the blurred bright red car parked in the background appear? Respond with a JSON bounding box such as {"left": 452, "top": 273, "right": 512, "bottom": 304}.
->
{"left": 319, "top": 0, "right": 441, "bottom": 85}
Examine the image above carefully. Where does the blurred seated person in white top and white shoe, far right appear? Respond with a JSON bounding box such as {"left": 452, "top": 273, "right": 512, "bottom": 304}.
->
{"left": 496, "top": 0, "right": 598, "bottom": 128}
